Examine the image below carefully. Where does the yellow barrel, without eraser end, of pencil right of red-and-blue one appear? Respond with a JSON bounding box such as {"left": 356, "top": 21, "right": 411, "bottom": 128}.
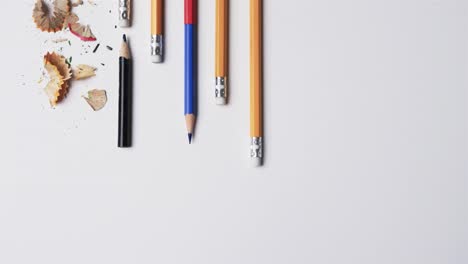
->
{"left": 215, "top": 0, "right": 229, "bottom": 77}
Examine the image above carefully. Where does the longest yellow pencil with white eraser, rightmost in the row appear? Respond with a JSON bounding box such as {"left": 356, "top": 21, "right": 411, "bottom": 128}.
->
{"left": 250, "top": 0, "right": 263, "bottom": 166}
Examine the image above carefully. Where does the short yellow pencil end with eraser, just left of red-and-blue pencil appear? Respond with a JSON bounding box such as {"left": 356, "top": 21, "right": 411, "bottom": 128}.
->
{"left": 151, "top": 0, "right": 164, "bottom": 63}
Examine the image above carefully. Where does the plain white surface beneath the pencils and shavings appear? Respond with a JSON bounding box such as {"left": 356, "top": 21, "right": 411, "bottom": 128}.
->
{"left": 0, "top": 0, "right": 468, "bottom": 264}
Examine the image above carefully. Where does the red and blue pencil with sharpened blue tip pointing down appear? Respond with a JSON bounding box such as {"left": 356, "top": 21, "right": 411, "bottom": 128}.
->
{"left": 184, "top": 0, "right": 197, "bottom": 144}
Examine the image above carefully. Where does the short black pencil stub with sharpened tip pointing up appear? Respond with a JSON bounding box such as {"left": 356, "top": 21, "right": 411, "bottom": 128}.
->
{"left": 118, "top": 35, "right": 132, "bottom": 148}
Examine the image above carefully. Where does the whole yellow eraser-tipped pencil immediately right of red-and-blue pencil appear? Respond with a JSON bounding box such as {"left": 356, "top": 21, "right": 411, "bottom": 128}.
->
{"left": 215, "top": 0, "right": 229, "bottom": 105}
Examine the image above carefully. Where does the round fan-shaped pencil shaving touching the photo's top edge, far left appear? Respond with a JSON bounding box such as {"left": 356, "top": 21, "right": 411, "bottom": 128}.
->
{"left": 33, "top": 0, "right": 70, "bottom": 32}
